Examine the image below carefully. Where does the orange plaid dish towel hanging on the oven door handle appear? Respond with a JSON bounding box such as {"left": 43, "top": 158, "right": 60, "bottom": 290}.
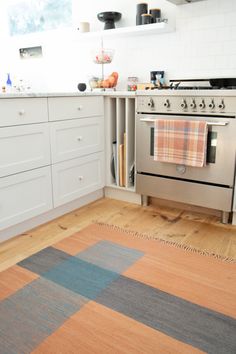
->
{"left": 154, "top": 119, "right": 208, "bottom": 167}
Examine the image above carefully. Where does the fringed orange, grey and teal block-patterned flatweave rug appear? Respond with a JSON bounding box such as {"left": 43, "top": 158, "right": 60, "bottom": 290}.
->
{"left": 0, "top": 224, "right": 236, "bottom": 354}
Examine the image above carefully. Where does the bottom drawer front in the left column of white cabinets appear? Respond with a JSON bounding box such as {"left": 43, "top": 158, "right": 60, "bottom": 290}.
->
{"left": 0, "top": 167, "right": 52, "bottom": 230}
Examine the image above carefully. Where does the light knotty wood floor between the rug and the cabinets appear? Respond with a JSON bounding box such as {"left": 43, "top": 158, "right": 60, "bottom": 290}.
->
{"left": 0, "top": 199, "right": 236, "bottom": 270}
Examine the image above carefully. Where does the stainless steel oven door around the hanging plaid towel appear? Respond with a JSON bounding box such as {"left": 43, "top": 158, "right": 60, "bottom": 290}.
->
{"left": 136, "top": 114, "right": 236, "bottom": 187}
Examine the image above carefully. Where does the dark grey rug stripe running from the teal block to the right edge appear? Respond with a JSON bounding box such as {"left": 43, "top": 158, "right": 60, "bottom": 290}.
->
{"left": 96, "top": 275, "right": 236, "bottom": 354}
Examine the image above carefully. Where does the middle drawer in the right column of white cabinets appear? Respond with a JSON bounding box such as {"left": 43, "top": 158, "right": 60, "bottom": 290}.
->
{"left": 50, "top": 117, "right": 104, "bottom": 163}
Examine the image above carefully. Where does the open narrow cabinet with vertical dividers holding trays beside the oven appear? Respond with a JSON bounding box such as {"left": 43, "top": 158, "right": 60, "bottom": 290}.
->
{"left": 105, "top": 97, "right": 135, "bottom": 191}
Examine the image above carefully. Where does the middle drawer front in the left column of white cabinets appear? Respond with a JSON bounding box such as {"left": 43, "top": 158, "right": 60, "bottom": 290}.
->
{"left": 0, "top": 123, "right": 50, "bottom": 177}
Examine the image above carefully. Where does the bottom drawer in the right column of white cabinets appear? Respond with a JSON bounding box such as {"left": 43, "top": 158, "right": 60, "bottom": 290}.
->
{"left": 52, "top": 153, "right": 104, "bottom": 207}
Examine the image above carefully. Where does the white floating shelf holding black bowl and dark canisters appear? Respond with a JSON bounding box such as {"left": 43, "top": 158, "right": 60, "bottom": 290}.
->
{"left": 76, "top": 22, "right": 175, "bottom": 39}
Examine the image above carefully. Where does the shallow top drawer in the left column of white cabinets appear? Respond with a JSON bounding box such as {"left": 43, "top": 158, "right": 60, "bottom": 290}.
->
{"left": 0, "top": 98, "right": 48, "bottom": 127}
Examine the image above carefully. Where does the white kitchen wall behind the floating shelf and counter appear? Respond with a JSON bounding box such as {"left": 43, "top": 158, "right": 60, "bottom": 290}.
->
{"left": 0, "top": 0, "right": 236, "bottom": 91}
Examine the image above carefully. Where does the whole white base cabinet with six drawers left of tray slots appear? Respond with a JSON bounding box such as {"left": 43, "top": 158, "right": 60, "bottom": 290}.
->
{"left": 0, "top": 96, "right": 104, "bottom": 240}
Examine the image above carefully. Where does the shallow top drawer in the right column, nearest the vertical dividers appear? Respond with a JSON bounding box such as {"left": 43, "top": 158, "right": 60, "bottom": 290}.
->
{"left": 48, "top": 96, "right": 103, "bottom": 121}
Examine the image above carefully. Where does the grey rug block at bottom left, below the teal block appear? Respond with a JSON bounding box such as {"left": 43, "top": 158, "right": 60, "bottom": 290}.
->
{"left": 0, "top": 278, "right": 88, "bottom": 354}
